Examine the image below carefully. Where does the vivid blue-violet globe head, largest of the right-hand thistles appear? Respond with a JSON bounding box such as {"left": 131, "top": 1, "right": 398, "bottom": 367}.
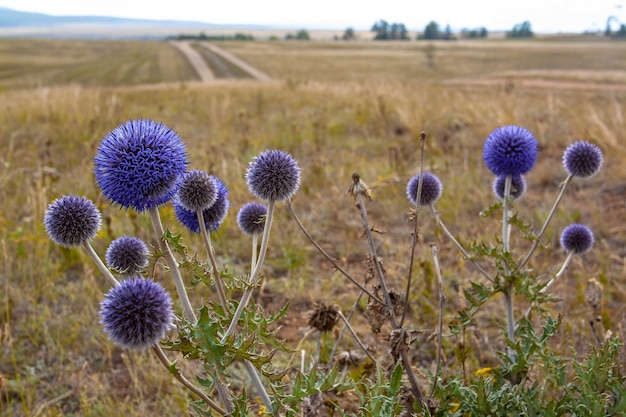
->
{"left": 483, "top": 125, "right": 537, "bottom": 177}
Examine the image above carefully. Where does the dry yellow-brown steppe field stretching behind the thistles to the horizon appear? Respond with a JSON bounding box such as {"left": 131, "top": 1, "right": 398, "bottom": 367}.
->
{"left": 0, "top": 38, "right": 626, "bottom": 417}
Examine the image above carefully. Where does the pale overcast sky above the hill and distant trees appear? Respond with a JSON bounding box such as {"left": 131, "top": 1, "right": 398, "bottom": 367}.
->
{"left": 0, "top": 0, "right": 626, "bottom": 32}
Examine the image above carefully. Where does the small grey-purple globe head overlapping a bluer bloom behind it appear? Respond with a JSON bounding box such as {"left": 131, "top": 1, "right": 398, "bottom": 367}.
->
{"left": 178, "top": 170, "right": 217, "bottom": 211}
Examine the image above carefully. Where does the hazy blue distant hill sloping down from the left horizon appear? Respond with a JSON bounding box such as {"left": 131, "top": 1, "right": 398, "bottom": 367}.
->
{"left": 0, "top": 7, "right": 265, "bottom": 38}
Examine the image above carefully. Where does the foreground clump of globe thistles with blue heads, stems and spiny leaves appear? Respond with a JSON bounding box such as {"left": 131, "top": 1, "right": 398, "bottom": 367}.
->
{"left": 44, "top": 114, "right": 626, "bottom": 417}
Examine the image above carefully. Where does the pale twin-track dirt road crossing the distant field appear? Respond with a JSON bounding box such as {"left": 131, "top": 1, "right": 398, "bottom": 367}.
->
{"left": 171, "top": 41, "right": 271, "bottom": 83}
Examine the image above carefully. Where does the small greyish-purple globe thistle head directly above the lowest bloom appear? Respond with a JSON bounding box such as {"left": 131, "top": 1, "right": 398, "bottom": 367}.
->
{"left": 105, "top": 236, "right": 149, "bottom": 275}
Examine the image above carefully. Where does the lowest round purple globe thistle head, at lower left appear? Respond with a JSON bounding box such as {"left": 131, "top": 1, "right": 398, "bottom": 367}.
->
{"left": 100, "top": 277, "right": 174, "bottom": 349}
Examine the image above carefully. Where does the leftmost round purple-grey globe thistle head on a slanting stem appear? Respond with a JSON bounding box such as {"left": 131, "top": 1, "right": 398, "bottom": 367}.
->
{"left": 43, "top": 195, "right": 102, "bottom": 248}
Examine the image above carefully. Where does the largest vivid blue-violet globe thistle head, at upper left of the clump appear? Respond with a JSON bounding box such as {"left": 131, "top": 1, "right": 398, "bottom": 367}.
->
{"left": 94, "top": 120, "right": 187, "bottom": 212}
